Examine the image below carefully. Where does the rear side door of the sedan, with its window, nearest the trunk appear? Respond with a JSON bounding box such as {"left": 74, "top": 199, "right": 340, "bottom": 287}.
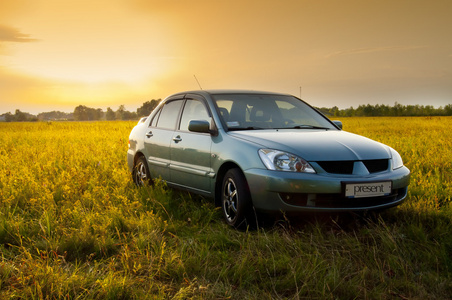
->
{"left": 144, "top": 99, "right": 184, "bottom": 181}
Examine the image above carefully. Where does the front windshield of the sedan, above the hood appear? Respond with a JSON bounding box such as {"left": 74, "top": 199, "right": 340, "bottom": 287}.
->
{"left": 213, "top": 94, "right": 337, "bottom": 130}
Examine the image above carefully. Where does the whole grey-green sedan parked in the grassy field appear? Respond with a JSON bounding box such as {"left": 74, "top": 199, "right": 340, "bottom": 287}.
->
{"left": 127, "top": 90, "right": 410, "bottom": 228}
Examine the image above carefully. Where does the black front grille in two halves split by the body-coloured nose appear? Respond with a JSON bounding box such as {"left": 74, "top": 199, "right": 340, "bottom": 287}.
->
{"left": 317, "top": 159, "right": 389, "bottom": 174}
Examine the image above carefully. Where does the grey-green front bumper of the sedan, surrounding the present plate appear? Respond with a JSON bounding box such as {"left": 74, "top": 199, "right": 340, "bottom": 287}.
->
{"left": 245, "top": 167, "right": 410, "bottom": 212}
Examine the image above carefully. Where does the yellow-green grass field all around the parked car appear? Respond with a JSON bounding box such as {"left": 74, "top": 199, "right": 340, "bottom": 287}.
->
{"left": 0, "top": 117, "right": 452, "bottom": 299}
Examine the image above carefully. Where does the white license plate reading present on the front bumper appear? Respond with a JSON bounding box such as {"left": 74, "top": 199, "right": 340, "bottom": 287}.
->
{"left": 345, "top": 181, "right": 392, "bottom": 198}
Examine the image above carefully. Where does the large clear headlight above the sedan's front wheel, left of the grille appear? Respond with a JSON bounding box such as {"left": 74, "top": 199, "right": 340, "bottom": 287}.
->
{"left": 259, "top": 149, "right": 315, "bottom": 173}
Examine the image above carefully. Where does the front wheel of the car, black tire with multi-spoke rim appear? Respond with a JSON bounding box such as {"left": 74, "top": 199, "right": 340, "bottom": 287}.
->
{"left": 221, "top": 168, "right": 254, "bottom": 228}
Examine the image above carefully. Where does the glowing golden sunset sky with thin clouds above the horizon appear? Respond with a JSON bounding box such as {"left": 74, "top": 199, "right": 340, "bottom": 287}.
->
{"left": 0, "top": 0, "right": 452, "bottom": 114}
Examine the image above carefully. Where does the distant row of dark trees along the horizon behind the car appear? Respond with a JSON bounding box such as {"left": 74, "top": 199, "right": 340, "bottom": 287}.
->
{"left": 0, "top": 99, "right": 452, "bottom": 122}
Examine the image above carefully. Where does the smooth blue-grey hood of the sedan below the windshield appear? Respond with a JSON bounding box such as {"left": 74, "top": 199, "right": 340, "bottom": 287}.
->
{"left": 228, "top": 129, "right": 391, "bottom": 161}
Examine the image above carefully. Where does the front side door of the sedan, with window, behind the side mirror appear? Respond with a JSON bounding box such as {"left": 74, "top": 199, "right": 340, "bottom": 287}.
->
{"left": 170, "top": 97, "right": 214, "bottom": 193}
